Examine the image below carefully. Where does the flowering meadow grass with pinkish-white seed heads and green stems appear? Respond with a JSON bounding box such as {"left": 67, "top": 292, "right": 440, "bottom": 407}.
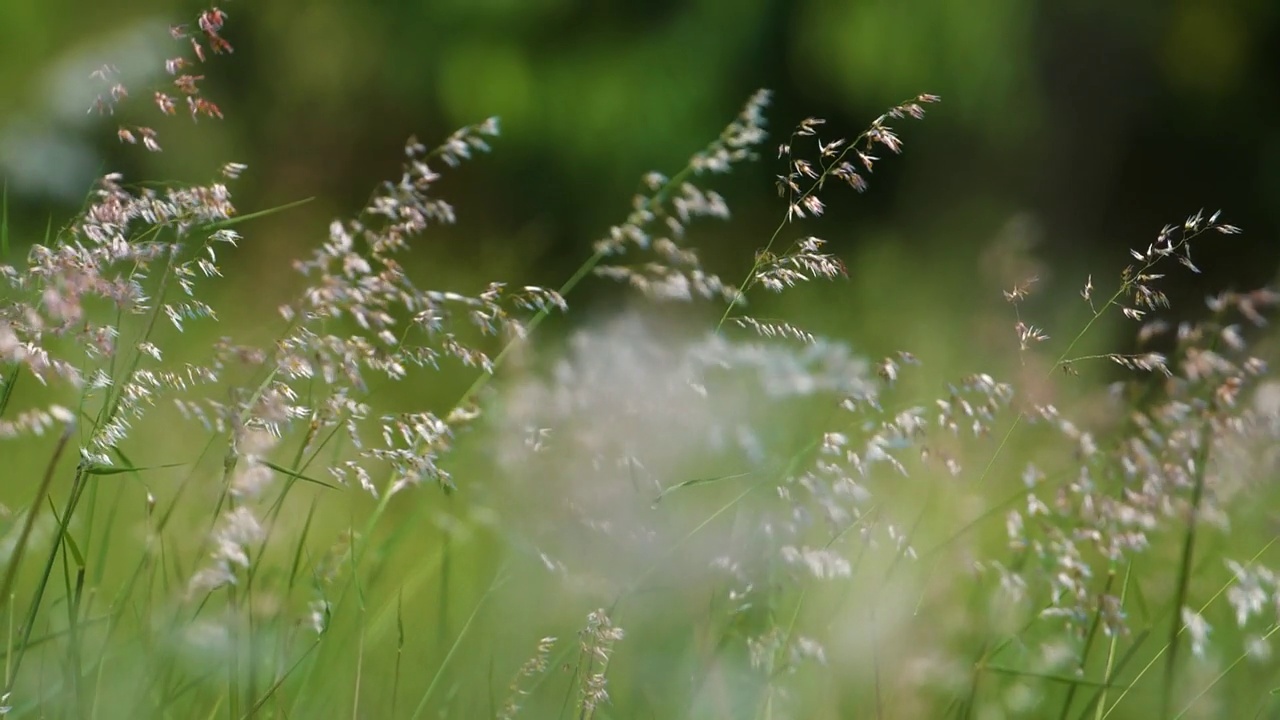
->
{"left": 0, "top": 2, "right": 1280, "bottom": 719}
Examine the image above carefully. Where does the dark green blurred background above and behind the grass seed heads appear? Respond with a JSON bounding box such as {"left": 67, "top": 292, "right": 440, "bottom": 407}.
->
{"left": 0, "top": 0, "right": 1280, "bottom": 333}
